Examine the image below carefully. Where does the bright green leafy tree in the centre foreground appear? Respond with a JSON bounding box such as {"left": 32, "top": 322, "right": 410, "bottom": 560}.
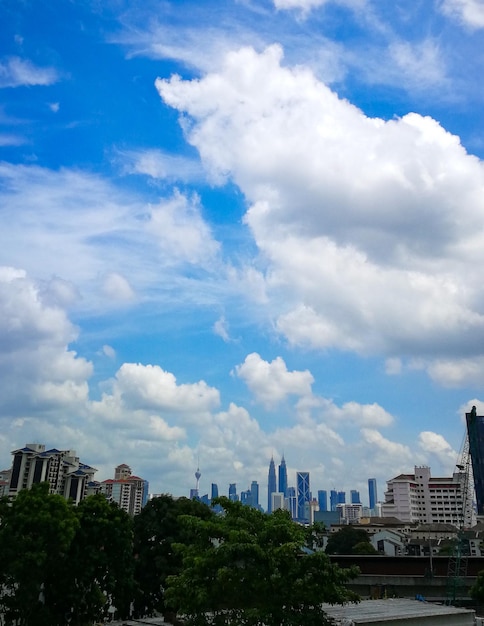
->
{"left": 166, "top": 498, "right": 358, "bottom": 626}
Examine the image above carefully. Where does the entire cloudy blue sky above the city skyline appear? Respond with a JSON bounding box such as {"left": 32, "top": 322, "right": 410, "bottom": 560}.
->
{"left": 0, "top": 0, "right": 484, "bottom": 502}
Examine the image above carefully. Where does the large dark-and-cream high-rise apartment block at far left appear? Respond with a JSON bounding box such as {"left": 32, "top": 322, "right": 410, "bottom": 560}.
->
{"left": 8, "top": 443, "right": 96, "bottom": 504}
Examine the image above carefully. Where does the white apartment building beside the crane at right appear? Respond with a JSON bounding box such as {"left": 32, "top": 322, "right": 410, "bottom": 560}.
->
{"left": 382, "top": 466, "right": 473, "bottom": 527}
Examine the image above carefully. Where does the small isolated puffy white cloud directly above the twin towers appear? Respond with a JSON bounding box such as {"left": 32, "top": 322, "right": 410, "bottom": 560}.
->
{"left": 235, "top": 352, "right": 314, "bottom": 408}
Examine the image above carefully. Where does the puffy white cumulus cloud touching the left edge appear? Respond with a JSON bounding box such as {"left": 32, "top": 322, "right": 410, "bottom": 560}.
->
{"left": 0, "top": 267, "right": 92, "bottom": 418}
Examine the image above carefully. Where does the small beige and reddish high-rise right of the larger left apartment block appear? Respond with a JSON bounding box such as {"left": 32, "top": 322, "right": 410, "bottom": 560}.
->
{"left": 100, "top": 463, "right": 148, "bottom": 515}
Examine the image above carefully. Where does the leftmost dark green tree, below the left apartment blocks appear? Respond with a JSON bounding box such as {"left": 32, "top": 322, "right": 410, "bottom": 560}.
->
{"left": 0, "top": 483, "right": 79, "bottom": 626}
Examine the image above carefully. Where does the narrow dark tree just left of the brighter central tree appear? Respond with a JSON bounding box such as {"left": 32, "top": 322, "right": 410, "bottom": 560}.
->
{"left": 134, "top": 494, "right": 213, "bottom": 616}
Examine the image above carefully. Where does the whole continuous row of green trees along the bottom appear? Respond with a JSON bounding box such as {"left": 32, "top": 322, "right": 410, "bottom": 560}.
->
{"left": 0, "top": 483, "right": 356, "bottom": 626}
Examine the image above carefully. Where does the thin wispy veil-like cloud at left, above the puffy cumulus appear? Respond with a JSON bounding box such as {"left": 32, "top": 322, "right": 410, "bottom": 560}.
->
{"left": 0, "top": 163, "right": 223, "bottom": 309}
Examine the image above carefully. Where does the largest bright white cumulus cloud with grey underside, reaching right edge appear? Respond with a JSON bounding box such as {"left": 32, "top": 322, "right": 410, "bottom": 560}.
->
{"left": 156, "top": 46, "right": 484, "bottom": 380}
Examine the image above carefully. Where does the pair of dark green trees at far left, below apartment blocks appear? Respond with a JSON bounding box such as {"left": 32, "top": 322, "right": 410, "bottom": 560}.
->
{"left": 0, "top": 483, "right": 133, "bottom": 626}
